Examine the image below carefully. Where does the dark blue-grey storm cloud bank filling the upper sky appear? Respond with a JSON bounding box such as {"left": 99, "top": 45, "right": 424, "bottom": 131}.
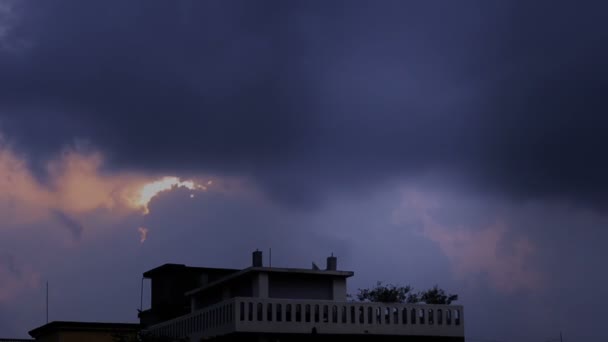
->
{"left": 0, "top": 1, "right": 608, "bottom": 205}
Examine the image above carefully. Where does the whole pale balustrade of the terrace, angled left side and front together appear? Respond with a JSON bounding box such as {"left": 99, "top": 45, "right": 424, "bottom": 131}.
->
{"left": 148, "top": 298, "right": 464, "bottom": 340}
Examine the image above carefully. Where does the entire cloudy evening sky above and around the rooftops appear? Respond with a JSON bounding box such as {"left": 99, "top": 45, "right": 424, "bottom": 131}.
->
{"left": 0, "top": 0, "right": 608, "bottom": 342}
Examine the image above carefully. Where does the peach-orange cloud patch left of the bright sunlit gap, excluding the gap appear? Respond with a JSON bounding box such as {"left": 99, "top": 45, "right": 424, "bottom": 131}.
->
{"left": 0, "top": 145, "right": 138, "bottom": 227}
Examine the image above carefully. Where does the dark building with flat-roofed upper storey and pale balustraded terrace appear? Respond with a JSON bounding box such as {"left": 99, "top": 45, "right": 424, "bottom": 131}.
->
{"left": 140, "top": 251, "right": 464, "bottom": 341}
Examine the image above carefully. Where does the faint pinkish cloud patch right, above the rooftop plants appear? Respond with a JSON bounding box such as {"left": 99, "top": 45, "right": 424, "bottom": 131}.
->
{"left": 395, "top": 192, "right": 542, "bottom": 292}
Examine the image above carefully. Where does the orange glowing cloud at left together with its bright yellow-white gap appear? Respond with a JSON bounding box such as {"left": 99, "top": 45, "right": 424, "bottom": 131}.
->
{"left": 0, "top": 142, "right": 213, "bottom": 230}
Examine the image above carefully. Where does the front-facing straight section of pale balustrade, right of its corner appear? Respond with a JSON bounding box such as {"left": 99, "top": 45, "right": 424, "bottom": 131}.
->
{"left": 235, "top": 298, "right": 464, "bottom": 337}
